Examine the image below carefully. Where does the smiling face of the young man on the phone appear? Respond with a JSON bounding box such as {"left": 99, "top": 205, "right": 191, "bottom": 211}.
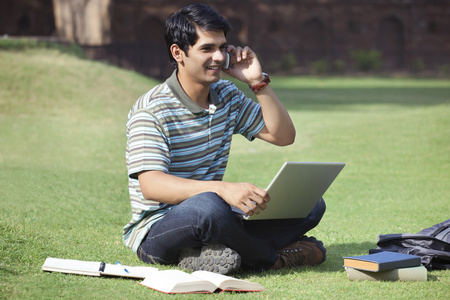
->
{"left": 183, "top": 27, "right": 227, "bottom": 85}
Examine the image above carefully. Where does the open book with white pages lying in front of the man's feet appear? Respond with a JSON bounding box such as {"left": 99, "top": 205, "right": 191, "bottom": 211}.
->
{"left": 140, "top": 270, "right": 264, "bottom": 294}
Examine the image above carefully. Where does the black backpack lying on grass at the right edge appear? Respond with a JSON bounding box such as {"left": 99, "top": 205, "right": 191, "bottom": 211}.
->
{"left": 370, "top": 219, "right": 450, "bottom": 270}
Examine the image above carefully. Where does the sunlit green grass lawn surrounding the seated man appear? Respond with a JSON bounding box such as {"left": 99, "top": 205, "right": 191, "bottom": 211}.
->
{"left": 0, "top": 45, "right": 450, "bottom": 299}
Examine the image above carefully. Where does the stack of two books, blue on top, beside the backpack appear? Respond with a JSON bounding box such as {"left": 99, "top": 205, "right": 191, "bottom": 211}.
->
{"left": 344, "top": 251, "right": 427, "bottom": 281}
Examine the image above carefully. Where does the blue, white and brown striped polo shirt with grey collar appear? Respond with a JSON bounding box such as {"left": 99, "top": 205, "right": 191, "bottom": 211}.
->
{"left": 123, "top": 71, "right": 265, "bottom": 252}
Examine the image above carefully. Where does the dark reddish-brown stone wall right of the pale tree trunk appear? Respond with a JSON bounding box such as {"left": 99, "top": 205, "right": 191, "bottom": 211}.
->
{"left": 102, "top": 0, "right": 450, "bottom": 77}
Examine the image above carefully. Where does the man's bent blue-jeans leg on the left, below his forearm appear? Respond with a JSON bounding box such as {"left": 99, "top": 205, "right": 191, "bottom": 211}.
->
{"left": 137, "top": 192, "right": 236, "bottom": 263}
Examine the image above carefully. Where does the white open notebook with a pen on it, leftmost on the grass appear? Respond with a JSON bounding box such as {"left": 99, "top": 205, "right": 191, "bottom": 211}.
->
{"left": 42, "top": 257, "right": 158, "bottom": 279}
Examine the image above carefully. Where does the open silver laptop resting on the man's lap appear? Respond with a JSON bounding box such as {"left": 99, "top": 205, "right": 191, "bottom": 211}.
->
{"left": 233, "top": 162, "right": 345, "bottom": 220}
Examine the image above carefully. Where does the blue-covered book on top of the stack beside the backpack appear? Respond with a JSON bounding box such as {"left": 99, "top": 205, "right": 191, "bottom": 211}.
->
{"left": 344, "top": 251, "right": 421, "bottom": 272}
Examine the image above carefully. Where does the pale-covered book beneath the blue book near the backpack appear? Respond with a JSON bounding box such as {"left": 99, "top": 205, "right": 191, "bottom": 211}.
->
{"left": 345, "top": 266, "right": 428, "bottom": 281}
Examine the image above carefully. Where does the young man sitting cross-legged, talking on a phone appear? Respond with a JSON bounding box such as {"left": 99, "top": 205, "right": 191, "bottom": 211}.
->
{"left": 124, "top": 4, "right": 325, "bottom": 274}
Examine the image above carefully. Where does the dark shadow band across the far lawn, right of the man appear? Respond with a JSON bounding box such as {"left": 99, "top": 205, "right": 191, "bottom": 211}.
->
{"left": 232, "top": 79, "right": 450, "bottom": 111}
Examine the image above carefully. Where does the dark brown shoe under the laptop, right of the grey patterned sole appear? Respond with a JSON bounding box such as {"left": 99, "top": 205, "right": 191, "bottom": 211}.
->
{"left": 273, "top": 237, "right": 326, "bottom": 269}
